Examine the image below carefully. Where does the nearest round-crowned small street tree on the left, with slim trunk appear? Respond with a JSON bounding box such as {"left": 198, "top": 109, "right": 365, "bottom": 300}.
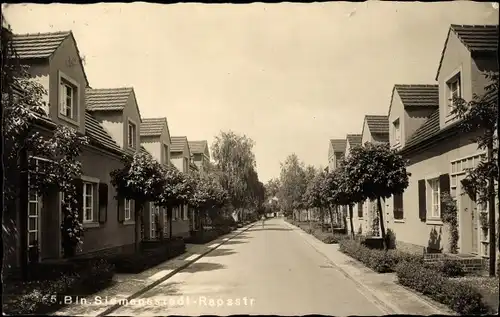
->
{"left": 110, "top": 152, "right": 167, "bottom": 250}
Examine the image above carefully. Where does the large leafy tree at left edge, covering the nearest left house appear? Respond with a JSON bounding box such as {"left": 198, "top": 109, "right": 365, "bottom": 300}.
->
{"left": 1, "top": 21, "right": 88, "bottom": 278}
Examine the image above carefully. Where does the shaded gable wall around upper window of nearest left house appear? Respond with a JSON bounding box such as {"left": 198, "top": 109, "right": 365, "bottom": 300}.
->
{"left": 49, "top": 36, "right": 87, "bottom": 133}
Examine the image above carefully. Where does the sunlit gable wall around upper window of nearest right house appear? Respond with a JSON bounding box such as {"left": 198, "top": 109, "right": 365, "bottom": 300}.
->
{"left": 438, "top": 31, "right": 472, "bottom": 128}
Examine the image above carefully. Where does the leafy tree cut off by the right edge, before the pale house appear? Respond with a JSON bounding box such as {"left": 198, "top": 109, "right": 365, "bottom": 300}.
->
{"left": 452, "top": 72, "right": 500, "bottom": 276}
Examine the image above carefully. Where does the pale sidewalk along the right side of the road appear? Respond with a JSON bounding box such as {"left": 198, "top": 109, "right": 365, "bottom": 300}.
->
{"left": 284, "top": 221, "right": 456, "bottom": 316}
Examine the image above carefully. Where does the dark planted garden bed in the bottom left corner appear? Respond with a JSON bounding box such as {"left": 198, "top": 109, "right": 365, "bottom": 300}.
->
{"left": 2, "top": 259, "right": 115, "bottom": 315}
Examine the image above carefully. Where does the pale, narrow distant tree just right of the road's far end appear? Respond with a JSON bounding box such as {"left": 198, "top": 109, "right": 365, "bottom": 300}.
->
{"left": 278, "top": 153, "right": 307, "bottom": 219}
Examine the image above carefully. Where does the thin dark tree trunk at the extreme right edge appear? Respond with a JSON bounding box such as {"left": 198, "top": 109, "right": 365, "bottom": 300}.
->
{"left": 487, "top": 139, "right": 497, "bottom": 277}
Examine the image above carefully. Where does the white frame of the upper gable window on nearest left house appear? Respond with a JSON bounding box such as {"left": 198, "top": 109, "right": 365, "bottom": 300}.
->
{"left": 57, "top": 71, "right": 80, "bottom": 126}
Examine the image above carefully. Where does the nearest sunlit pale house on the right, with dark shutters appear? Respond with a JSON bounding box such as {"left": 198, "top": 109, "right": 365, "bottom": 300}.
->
{"left": 388, "top": 25, "right": 498, "bottom": 258}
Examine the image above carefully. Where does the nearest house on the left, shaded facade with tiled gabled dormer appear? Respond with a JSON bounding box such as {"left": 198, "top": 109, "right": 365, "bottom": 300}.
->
{"left": 3, "top": 32, "right": 138, "bottom": 276}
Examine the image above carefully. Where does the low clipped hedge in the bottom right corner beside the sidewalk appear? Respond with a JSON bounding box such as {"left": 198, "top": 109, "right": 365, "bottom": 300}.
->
{"left": 396, "top": 261, "right": 489, "bottom": 315}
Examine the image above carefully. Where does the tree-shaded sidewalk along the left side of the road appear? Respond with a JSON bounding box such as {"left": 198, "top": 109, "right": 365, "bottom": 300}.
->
{"left": 52, "top": 224, "right": 254, "bottom": 316}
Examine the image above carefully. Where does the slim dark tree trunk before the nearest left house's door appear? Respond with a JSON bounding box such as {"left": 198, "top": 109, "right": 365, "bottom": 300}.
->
{"left": 19, "top": 147, "right": 29, "bottom": 280}
